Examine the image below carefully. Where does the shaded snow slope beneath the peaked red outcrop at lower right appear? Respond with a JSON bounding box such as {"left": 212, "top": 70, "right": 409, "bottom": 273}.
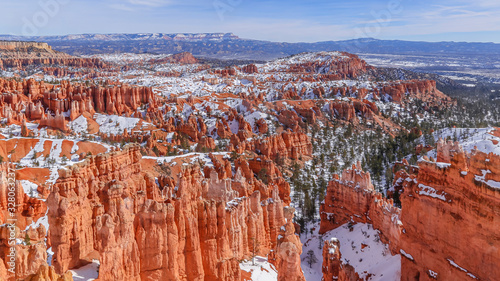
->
{"left": 301, "top": 223, "right": 401, "bottom": 281}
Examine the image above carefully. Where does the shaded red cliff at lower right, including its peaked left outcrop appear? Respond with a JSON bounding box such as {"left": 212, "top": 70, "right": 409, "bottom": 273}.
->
{"left": 320, "top": 136, "right": 500, "bottom": 281}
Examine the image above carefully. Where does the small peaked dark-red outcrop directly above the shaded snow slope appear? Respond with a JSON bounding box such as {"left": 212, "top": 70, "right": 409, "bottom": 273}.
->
{"left": 319, "top": 163, "right": 402, "bottom": 254}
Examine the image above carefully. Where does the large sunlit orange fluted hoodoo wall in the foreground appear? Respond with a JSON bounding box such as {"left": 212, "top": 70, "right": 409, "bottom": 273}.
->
{"left": 47, "top": 143, "right": 303, "bottom": 280}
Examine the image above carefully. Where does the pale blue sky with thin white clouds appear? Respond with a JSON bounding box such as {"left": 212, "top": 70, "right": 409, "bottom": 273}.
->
{"left": 0, "top": 0, "right": 500, "bottom": 43}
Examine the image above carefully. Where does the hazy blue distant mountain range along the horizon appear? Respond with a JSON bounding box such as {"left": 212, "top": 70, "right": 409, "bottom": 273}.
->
{"left": 0, "top": 33, "right": 500, "bottom": 60}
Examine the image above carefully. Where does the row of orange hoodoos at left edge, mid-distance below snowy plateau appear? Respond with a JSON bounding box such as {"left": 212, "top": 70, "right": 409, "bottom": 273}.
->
{"left": 0, "top": 79, "right": 157, "bottom": 132}
